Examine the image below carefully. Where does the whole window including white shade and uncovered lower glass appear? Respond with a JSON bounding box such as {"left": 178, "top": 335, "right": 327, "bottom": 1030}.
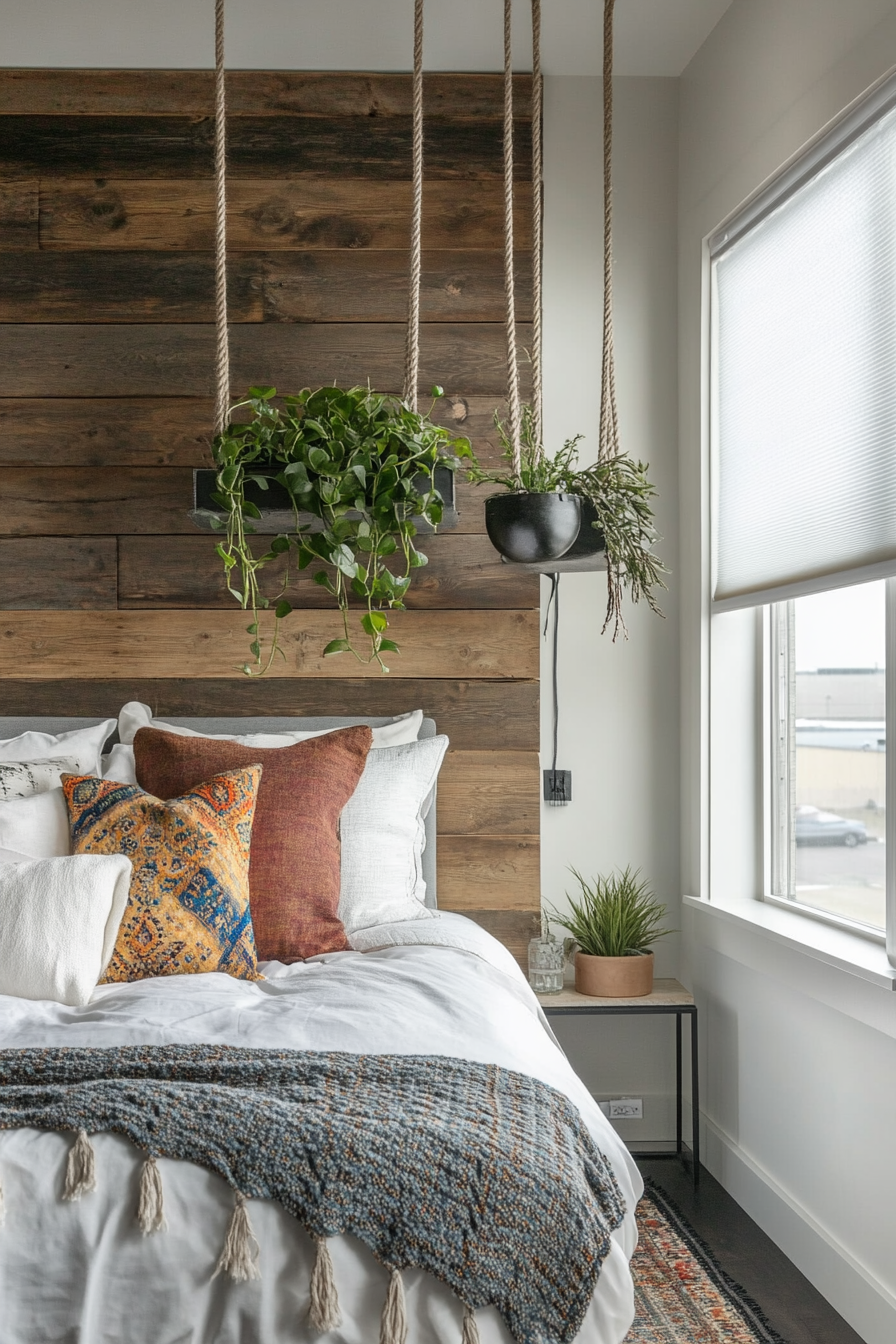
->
{"left": 709, "top": 81, "right": 896, "bottom": 965}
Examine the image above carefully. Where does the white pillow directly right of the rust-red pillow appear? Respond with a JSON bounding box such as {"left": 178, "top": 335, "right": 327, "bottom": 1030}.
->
{"left": 339, "top": 737, "right": 449, "bottom": 935}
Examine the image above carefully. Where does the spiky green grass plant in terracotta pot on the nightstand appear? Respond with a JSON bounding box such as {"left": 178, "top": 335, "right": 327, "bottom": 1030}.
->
{"left": 549, "top": 867, "right": 672, "bottom": 999}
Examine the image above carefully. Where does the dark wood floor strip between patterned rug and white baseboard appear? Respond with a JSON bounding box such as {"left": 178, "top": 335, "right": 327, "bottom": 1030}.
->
{"left": 638, "top": 1160, "right": 862, "bottom": 1344}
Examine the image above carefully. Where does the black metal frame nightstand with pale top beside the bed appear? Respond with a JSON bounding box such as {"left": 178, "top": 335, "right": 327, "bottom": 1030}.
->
{"left": 536, "top": 980, "right": 700, "bottom": 1185}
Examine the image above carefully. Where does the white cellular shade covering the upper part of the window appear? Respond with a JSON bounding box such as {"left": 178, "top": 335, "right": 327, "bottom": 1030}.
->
{"left": 712, "top": 99, "right": 896, "bottom": 609}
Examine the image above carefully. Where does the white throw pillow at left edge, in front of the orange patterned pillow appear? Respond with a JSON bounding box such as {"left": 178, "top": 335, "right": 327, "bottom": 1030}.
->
{"left": 0, "top": 853, "right": 132, "bottom": 1008}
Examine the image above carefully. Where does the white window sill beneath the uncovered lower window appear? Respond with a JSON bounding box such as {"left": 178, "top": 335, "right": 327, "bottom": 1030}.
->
{"left": 682, "top": 896, "right": 896, "bottom": 993}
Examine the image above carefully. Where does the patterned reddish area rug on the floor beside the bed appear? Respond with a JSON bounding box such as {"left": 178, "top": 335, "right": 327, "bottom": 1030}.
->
{"left": 626, "top": 1181, "right": 786, "bottom": 1344}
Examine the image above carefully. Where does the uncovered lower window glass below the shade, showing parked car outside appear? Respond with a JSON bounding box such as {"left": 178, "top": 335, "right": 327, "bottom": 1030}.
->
{"left": 767, "top": 581, "right": 887, "bottom": 931}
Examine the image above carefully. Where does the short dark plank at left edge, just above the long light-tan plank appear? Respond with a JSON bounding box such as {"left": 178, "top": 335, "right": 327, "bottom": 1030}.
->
{"left": 0, "top": 536, "right": 118, "bottom": 612}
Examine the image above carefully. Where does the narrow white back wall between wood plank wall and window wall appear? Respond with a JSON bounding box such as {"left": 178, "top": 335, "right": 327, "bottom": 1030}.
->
{"left": 541, "top": 78, "right": 680, "bottom": 1141}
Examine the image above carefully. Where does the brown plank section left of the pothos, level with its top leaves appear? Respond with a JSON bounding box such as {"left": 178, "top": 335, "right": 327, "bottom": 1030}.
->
{"left": 0, "top": 396, "right": 214, "bottom": 466}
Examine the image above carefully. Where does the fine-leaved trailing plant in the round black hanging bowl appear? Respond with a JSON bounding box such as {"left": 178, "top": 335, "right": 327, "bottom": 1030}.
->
{"left": 469, "top": 406, "right": 668, "bottom": 642}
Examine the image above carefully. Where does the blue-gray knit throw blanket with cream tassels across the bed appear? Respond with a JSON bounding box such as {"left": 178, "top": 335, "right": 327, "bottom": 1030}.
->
{"left": 0, "top": 1046, "right": 623, "bottom": 1344}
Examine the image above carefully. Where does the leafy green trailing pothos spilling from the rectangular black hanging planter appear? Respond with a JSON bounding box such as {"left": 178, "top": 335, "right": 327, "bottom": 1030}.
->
{"left": 201, "top": 387, "right": 474, "bottom": 676}
